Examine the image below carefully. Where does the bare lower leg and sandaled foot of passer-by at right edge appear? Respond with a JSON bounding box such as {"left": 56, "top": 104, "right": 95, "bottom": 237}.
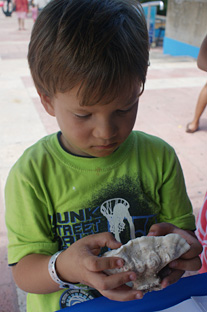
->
{"left": 186, "top": 83, "right": 207, "bottom": 133}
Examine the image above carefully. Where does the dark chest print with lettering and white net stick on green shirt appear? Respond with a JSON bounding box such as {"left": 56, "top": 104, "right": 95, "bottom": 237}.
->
{"left": 49, "top": 176, "right": 159, "bottom": 249}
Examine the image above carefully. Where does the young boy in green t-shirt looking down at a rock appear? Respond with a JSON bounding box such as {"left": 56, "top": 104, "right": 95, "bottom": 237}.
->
{"left": 6, "top": 0, "right": 201, "bottom": 312}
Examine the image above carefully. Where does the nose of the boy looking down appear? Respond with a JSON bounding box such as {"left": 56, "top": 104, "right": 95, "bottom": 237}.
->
{"left": 93, "top": 119, "right": 118, "bottom": 140}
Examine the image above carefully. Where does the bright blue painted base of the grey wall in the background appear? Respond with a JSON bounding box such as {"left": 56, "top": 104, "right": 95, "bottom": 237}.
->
{"left": 163, "top": 37, "right": 199, "bottom": 58}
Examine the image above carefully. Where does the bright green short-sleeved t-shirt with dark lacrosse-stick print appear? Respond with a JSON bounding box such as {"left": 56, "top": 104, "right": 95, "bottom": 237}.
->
{"left": 5, "top": 131, "right": 195, "bottom": 312}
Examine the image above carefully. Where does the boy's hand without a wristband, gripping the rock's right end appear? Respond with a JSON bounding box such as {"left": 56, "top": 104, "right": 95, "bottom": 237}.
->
{"left": 148, "top": 222, "right": 202, "bottom": 288}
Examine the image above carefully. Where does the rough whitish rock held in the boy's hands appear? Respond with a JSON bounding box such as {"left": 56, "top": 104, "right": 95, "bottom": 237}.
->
{"left": 103, "top": 234, "right": 190, "bottom": 292}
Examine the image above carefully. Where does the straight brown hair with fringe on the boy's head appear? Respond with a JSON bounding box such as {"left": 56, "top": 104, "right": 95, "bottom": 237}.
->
{"left": 28, "top": 0, "right": 149, "bottom": 105}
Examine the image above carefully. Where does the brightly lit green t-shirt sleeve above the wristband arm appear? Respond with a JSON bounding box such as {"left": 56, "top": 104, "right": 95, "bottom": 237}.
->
{"left": 5, "top": 165, "right": 58, "bottom": 265}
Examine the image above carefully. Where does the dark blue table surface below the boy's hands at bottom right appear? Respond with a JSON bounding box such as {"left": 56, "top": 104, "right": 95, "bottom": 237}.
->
{"left": 56, "top": 273, "right": 207, "bottom": 312}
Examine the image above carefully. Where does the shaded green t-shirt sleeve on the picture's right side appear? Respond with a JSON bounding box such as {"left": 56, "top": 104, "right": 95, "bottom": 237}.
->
{"left": 160, "top": 147, "right": 195, "bottom": 230}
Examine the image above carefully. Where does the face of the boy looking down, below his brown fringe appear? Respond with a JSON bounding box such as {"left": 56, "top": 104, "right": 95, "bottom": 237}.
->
{"left": 40, "top": 84, "right": 140, "bottom": 157}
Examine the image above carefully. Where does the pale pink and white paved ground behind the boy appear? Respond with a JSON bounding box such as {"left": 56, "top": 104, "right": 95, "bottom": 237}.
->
{"left": 0, "top": 8, "right": 207, "bottom": 312}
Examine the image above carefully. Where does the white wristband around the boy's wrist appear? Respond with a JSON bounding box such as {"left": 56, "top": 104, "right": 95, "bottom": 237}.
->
{"left": 48, "top": 250, "right": 92, "bottom": 290}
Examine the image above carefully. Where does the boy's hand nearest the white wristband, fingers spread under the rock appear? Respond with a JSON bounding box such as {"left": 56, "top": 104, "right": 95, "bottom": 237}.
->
{"left": 56, "top": 232, "right": 143, "bottom": 301}
